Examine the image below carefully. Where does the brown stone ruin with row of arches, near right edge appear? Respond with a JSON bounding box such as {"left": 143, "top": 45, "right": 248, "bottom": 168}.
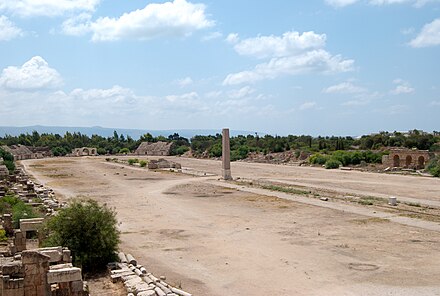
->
{"left": 382, "top": 148, "right": 431, "bottom": 170}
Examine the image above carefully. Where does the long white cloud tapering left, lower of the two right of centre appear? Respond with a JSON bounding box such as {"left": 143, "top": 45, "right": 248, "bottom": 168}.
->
{"left": 223, "top": 49, "right": 354, "bottom": 85}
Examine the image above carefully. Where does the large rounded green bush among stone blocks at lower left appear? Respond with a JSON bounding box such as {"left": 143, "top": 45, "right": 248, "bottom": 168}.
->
{"left": 44, "top": 199, "right": 119, "bottom": 271}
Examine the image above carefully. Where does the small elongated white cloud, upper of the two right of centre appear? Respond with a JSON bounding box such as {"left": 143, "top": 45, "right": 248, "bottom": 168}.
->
{"left": 234, "top": 31, "right": 326, "bottom": 58}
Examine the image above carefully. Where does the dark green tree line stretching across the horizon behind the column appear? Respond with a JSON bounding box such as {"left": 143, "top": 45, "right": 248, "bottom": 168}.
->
{"left": 0, "top": 130, "right": 440, "bottom": 160}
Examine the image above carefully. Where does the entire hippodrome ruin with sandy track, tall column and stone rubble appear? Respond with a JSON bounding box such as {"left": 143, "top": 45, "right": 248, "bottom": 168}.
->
{"left": 0, "top": 129, "right": 440, "bottom": 296}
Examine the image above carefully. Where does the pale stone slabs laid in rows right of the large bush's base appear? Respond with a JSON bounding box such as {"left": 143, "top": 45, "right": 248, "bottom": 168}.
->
{"left": 109, "top": 252, "right": 192, "bottom": 296}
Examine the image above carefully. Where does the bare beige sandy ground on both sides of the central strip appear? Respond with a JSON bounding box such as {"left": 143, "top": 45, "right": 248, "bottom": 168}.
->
{"left": 23, "top": 158, "right": 440, "bottom": 296}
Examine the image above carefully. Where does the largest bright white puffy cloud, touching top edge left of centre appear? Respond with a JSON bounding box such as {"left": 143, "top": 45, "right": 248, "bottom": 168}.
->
{"left": 75, "top": 0, "right": 214, "bottom": 41}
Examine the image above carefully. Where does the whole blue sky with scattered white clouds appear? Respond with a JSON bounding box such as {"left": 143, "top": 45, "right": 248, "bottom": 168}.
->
{"left": 0, "top": 0, "right": 440, "bottom": 136}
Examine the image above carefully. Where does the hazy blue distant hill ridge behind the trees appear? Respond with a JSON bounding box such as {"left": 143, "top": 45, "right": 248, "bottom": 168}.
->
{"left": 0, "top": 125, "right": 265, "bottom": 140}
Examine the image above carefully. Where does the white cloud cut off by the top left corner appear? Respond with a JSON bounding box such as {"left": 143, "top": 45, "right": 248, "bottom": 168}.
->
{"left": 0, "top": 0, "right": 100, "bottom": 17}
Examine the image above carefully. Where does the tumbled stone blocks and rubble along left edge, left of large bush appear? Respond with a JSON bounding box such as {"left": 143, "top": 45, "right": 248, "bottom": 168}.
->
{"left": 0, "top": 170, "right": 89, "bottom": 296}
